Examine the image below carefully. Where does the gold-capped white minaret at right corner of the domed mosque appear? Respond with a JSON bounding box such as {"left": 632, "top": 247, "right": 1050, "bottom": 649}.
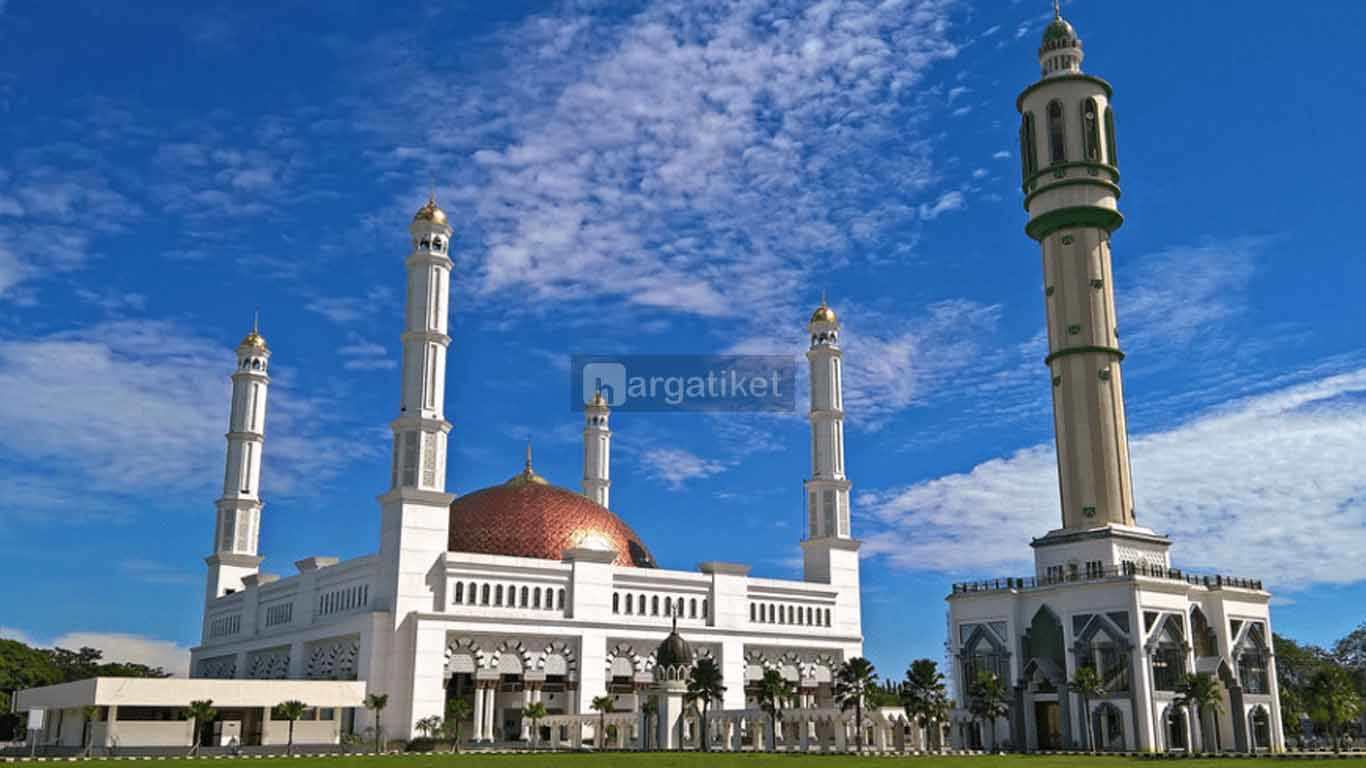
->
{"left": 802, "top": 298, "right": 861, "bottom": 634}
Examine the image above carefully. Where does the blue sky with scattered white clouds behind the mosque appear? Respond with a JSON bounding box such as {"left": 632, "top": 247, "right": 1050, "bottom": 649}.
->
{"left": 0, "top": 0, "right": 1366, "bottom": 675}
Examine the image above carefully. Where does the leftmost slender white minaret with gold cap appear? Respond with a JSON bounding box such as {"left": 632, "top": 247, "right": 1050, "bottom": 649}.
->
{"left": 205, "top": 317, "right": 270, "bottom": 603}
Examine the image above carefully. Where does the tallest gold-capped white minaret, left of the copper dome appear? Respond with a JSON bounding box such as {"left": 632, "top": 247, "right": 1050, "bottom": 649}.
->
{"left": 369, "top": 200, "right": 454, "bottom": 738}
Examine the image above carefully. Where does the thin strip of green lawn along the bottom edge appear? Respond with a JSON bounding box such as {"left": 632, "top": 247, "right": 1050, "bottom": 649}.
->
{"left": 56, "top": 752, "right": 1366, "bottom": 768}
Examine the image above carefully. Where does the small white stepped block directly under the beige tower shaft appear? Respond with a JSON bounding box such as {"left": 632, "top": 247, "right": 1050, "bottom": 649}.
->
{"left": 1030, "top": 523, "right": 1172, "bottom": 578}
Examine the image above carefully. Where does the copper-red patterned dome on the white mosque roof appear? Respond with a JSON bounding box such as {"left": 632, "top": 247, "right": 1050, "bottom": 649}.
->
{"left": 449, "top": 476, "right": 656, "bottom": 568}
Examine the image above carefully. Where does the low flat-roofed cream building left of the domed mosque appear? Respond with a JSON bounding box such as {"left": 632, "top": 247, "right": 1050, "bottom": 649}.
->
{"left": 14, "top": 678, "right": 365, "bottom": 750}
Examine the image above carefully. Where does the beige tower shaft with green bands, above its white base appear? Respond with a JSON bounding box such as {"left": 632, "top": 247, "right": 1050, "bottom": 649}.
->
{"left": 1015, "top": 4, "right": 1135, "bottom": 530}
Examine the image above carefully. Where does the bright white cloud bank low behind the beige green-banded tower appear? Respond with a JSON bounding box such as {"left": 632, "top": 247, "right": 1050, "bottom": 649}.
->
{"left": 858, "top": 369, "right": 1366, "bottom": 588}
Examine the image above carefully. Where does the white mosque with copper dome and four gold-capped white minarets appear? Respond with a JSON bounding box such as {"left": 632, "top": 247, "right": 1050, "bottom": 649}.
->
{"left": 191, "top": 194, "right": 863, "bottom": 743}
